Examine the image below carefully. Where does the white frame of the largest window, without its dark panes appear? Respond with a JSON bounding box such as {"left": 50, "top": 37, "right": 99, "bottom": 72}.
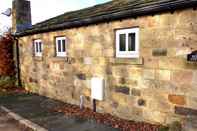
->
{"left": 116, "top": 27, "right": 140, "bottom": 58}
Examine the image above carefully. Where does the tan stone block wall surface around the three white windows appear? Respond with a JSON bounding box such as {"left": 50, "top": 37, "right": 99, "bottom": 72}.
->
{"left": 19, "top": 9, "right": 197, "bottom": 124}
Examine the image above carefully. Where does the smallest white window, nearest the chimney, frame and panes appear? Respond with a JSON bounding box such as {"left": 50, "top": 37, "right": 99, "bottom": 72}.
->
{"left": 33, "top": 39, "right": 43, "bottom": 56}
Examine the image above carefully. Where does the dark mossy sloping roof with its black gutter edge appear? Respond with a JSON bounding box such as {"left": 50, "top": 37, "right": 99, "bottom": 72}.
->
{"left": 16, "top": 0, "right": 197, "bottom": 36}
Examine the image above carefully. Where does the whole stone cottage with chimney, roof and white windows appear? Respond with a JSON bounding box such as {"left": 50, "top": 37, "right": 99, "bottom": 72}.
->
{"left": 13, "top": 0, "right": 197, "bottom": 128}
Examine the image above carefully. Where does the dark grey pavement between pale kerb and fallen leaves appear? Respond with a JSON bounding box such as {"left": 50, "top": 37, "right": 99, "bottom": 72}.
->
{"left": 0, "top": 94, "right": 119, "bottom": 131}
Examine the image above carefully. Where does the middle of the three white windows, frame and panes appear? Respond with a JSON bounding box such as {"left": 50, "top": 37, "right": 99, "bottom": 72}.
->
{"left": 56, "top": 37, "right": 66, "bottom": 57}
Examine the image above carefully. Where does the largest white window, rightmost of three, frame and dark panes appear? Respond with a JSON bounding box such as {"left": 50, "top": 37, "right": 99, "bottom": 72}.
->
{"left": 116, "top": 28, "right": 139, "bottom": 58}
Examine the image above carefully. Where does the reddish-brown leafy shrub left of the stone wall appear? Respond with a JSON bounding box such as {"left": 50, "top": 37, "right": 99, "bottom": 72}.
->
{"left": 0, "top": 34, "right": 15, "bottom": 88}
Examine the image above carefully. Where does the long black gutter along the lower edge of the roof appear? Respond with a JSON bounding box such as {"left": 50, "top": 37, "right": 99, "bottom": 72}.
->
{"left": 16, "top": 0, "right": 197, "bottom": 37}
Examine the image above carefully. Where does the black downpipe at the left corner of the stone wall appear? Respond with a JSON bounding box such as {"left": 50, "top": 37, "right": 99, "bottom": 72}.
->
{"left": 14, "top": 36, "right": 22, "bottom": 87}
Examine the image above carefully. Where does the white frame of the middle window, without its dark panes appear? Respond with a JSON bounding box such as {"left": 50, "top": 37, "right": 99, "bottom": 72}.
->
{"left": 55, "top": 37, "right": 67, "bottom": 57}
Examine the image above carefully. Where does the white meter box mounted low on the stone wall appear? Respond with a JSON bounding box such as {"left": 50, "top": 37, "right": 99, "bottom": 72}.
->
{"left": 91, "top": 77, "right": 105, "bottom": 101}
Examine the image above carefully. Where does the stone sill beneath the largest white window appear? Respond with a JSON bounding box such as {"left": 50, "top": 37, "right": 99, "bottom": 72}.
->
{"left": 110, "top": 57, "right": 144, "bottom": 65}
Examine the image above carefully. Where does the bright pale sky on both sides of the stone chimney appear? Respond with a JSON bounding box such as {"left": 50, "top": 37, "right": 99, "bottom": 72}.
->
{"left": 0, "top": 0, "right": 110, "bottom": 33}
